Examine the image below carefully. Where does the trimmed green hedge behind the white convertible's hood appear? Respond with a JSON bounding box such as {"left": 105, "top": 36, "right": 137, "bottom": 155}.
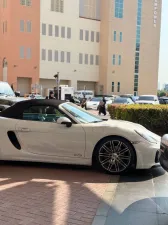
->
{"left": 108, "top": 104, "right": 168, "bottom": 135}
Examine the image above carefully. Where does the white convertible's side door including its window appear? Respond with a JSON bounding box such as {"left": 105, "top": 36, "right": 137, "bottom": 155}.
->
{"left": 16, "top": 106, "right": 85, "bottom": 157}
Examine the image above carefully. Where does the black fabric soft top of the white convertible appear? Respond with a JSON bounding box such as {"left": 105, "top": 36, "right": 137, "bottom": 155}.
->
{"left": 0, "top": 99, "right": 65, "bottom": 119}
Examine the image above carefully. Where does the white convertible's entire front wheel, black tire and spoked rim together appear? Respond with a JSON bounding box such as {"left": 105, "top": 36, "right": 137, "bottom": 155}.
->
{"left": 93, "top": 136, "right": 136, "bottom": 174}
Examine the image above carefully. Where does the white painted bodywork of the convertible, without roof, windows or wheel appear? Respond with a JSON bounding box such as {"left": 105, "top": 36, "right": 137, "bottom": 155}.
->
{"left": 0, "top": 117, "right": 160, "bottom": 169}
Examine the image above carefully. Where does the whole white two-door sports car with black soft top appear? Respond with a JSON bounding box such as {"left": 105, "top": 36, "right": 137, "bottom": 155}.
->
{"left": 0, "top": 100, "right": 160, "bottom": 174}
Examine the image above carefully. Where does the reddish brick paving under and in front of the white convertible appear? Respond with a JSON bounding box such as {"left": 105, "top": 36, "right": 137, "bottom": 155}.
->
{"left": 0, "top": 163, "right": 116, "bottom": 225}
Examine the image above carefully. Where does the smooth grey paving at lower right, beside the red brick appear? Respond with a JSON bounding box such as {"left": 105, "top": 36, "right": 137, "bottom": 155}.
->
{"left": 92, "top": 168, "right": 168, "bottom": 225}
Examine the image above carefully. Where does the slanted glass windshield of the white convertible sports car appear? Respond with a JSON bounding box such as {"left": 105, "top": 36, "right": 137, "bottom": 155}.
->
{"left": 61, "top": 103, "right": 103, "bottom": 124}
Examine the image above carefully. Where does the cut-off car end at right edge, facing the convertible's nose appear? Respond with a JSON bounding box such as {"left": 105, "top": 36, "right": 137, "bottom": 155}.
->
{"left": 159, "top": 134, "right": 168, "bottom": 172}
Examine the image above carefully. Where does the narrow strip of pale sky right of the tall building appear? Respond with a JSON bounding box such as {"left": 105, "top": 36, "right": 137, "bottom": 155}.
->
{"left": 159, "top": 0, "right": 168, "bottom": 88}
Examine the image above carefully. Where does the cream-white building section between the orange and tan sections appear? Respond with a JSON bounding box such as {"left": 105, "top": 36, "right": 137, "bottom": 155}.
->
{"left": 40, "top": 0, "right": 100, "bottom": 95}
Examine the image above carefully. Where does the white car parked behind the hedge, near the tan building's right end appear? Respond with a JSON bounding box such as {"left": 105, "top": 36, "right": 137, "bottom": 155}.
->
{"left": 136, "top": 95, "right": 159, "bottom": 105}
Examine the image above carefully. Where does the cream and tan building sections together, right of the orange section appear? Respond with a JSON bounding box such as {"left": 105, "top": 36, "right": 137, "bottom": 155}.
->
{"left": 39, "top": 0, "right": 161, "bottom": 95}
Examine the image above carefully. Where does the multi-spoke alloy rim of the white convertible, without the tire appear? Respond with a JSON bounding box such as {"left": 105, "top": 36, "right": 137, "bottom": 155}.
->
{"left": 99, "top": 140, "right": 132, "bottom": 173}
